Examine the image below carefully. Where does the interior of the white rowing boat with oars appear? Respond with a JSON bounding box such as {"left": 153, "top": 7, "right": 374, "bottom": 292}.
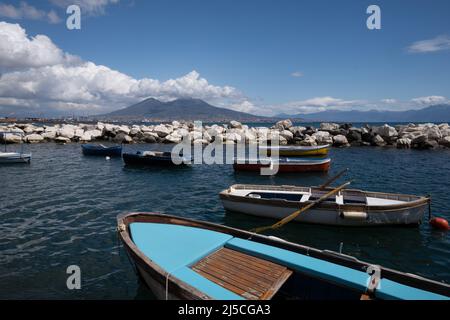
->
{"left": 228, "top": 186, "right": 420, "bottom": 206}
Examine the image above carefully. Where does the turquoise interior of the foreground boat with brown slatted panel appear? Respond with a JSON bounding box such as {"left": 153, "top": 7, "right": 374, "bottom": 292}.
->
{"left": 129, "top": 222, "right": 442, "bottom": 300}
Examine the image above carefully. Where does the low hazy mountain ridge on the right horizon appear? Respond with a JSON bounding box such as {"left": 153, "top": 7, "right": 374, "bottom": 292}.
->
{"left": 277, "top": 104, "right": 450, "bottom": 122}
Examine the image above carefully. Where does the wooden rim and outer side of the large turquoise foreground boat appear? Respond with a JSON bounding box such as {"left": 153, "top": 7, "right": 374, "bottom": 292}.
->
{"left": 117, "top": 212, "right": 450, "bottom": 299}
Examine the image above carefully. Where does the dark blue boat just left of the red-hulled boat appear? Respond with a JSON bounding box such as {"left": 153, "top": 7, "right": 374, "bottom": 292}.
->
{"left": 122, "top": 151, "right": 190, "bottom": 166}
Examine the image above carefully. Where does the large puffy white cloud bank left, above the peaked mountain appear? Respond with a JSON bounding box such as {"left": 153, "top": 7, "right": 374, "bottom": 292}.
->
{"left": 0, "top": 22, "right": 241, "bottom": 113}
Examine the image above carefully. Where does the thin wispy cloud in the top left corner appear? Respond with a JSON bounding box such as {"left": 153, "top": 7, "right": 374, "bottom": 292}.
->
{"left": 0, "top": 1, "right": 62, "bottom": 23}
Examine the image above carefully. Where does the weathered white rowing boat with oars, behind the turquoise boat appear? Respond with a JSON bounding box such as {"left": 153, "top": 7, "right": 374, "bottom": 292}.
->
{"left": 220, "top": 184, "right": 430, "bottom": 226}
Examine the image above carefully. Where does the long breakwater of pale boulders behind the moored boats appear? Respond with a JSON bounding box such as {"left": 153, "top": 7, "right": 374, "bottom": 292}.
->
{"left": 0, "top": 120, "right": 450, "bottom": 149}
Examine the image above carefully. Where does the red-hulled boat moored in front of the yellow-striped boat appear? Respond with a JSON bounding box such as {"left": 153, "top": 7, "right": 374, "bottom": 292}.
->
{"left": 233, "top": 157, "right": 331, "bottom": 173}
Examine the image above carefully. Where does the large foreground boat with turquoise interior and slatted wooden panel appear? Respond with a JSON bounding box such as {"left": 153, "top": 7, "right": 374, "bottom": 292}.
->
{"left": 117, "top": 213, "right": 450, "bottom": 300}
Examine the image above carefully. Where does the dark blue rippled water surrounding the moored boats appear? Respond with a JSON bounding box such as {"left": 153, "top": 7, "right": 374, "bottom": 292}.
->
{"left": 0, "top": 144, "right": 450, "bottom": 299}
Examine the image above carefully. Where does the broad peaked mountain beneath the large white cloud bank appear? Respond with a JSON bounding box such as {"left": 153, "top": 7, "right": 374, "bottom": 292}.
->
{"left": 96, "top": 98, "right": 269, "bottom": 122}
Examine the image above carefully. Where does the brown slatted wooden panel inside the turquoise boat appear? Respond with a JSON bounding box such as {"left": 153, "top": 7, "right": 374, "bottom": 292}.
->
{"left": 191, "top": 248, "right": 292, "bottom": 300}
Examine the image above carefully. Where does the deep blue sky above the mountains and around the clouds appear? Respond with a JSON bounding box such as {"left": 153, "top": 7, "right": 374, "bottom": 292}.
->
{"left": 0, "top": 0, "right": 450, "bottom": 114}
